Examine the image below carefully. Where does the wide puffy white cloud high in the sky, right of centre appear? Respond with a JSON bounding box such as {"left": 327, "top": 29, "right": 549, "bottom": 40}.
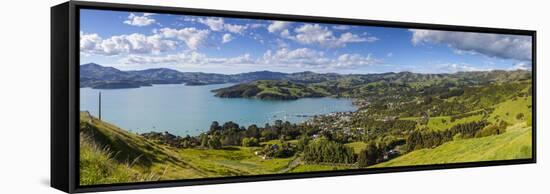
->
{"left": 281, "top": 24, "right": 378, "bottom": 48}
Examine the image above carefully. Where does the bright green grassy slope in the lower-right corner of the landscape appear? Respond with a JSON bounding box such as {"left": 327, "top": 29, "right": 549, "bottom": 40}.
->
{"left": 373, "top": 98, "right": 532, "bottom": 167}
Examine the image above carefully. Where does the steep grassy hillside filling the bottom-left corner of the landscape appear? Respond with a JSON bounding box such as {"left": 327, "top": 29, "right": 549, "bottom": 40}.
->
{"left": 80, "top": 112, "right": 206, "bottom": 185}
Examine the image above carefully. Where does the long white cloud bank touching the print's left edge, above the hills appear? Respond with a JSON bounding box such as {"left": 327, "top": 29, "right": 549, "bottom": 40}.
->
{"left": 80, "top": 32, "right": 176, "bottom": 55}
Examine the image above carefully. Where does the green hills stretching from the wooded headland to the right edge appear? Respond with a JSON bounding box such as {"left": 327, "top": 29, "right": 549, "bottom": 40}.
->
{"left": 213, "top": 71, "right": 531, "bottom": 100}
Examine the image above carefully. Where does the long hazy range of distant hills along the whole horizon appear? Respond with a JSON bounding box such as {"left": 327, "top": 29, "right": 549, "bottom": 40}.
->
{"left": 80, "top": 63, "right": 531, "bottom": 90}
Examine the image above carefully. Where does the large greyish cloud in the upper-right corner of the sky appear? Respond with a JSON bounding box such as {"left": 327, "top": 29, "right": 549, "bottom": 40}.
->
{"left": 410, "top": 29, "right": 532, "bottom": 61}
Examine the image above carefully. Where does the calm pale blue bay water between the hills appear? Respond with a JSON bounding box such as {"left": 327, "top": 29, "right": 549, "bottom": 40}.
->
{"left": 80, "top": 84, "right": 356, "bottom": 135}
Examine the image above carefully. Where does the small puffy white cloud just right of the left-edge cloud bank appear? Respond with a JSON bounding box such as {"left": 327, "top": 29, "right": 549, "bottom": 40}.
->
{"left": 159, "top": 27, "right": 210, "bottom": 50}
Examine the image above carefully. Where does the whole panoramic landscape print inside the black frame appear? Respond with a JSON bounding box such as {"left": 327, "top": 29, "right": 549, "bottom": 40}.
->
{"left": 78, "top": 9, "right": 533, "bottom": 186}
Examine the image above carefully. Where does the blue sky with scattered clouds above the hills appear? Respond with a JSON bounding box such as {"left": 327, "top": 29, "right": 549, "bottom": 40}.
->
{"left": 80, "top": 9, "right": 532, "bottom": 74}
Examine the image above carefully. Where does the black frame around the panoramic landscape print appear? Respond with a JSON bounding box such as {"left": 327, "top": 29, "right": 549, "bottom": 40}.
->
{"left": 51, "top": 1, "right": 536, "bottom": 193}
